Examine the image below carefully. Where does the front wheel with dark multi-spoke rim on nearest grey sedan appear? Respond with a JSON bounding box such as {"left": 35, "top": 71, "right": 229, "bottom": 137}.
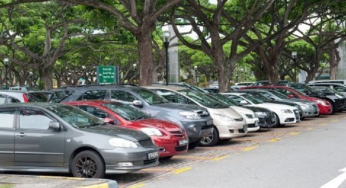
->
{"left": 71, "top": 150, "right": 105, "bottom": 178}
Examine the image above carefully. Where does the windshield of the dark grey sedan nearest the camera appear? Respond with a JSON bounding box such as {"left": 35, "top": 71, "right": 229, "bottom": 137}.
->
{"left": 47, "top": 105, "right": 105, "bottom": 128}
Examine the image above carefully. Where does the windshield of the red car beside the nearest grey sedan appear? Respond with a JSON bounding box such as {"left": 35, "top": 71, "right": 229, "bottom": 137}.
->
{"left": 103, "top": 103, "right": 150, "bottom": 121}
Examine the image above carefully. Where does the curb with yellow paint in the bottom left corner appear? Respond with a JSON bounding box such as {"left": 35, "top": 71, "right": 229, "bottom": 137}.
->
{"left": 0, "top": 174, "right": 118, "bottom": 188}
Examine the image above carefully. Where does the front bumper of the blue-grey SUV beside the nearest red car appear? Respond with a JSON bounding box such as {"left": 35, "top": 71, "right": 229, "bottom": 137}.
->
{"left": 181, "top": 118, "right": 213, "bottom": 143}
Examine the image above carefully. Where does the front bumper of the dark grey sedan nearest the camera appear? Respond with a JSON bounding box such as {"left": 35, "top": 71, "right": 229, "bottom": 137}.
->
{"left": 100, "top": 147, "right": 159, "bottom": 174}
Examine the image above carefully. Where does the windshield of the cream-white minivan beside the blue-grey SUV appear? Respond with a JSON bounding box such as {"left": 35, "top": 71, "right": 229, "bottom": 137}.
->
{"left": 178, "top": 89, "right": 228, "bottom": 108}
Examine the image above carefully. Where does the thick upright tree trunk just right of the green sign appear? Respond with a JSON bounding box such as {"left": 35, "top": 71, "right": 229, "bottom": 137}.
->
{"left": 137, "top": 29, "right": 153, "bottom": 86}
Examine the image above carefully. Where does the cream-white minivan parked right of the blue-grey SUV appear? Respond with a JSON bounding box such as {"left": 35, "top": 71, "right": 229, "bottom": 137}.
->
{"left": 146, "top": 86, "right": 249, "bottom": 146}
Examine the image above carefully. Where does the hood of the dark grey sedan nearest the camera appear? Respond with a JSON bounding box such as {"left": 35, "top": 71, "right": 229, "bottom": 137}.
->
{"left": 80, "top": 125, "right": 150, "bottom": 141}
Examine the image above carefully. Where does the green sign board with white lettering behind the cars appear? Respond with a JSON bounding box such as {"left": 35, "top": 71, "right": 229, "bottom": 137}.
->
{"left": 97, "top": 66, "right": 119, "bottom": 84}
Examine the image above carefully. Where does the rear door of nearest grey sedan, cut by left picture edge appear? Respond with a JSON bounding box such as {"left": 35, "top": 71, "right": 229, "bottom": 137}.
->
{"left": 0, "top": 108, "right": 15, "bottom": 167}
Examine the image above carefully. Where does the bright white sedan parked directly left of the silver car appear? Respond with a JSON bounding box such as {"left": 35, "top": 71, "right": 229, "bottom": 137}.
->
{"left": 222, "top": 93, "right": 300, "bottom": 126}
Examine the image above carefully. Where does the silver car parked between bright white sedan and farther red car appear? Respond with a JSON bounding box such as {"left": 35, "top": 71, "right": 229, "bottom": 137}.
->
{"left": 238, "top": 89, "right": 319, "bottom": 118}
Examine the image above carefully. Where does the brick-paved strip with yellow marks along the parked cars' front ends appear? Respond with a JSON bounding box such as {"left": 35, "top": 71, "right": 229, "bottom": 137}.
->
{"left": 106, "top": 112, "right": 346, "bottom": 188}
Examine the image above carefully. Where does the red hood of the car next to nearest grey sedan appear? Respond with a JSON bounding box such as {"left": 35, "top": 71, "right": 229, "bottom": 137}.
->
{"left": 133, "top": 118, "right": 181, "bottom": 131}
